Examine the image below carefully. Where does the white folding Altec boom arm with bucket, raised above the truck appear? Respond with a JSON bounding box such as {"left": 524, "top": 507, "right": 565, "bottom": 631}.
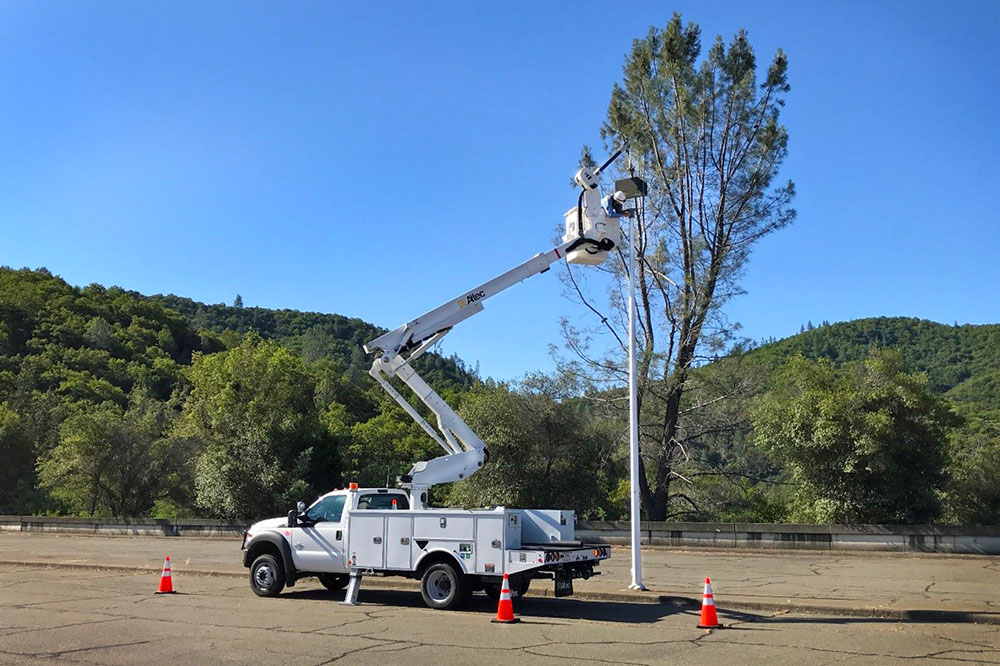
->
{"left": 365, "top": 157, "right": 620, "bottom": 508}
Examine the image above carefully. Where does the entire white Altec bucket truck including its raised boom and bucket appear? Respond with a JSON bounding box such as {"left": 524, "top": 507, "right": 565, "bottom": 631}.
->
{"left": 243, "top": 150, "right": 635, "bottom": 609}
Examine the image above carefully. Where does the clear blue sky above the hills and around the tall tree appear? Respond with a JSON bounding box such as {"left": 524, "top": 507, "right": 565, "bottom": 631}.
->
{"left": 0, "top": 0, "right": 1000, "bottom": 378}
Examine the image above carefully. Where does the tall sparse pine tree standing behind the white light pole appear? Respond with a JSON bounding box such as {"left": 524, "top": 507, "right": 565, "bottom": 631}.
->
{"left": 564, "top": 14, "right": 795, "bottom": 520}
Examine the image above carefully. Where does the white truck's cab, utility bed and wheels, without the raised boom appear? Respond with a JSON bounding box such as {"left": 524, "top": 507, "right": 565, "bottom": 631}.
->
{"left": 243, "top": 487, "right": 610, "bottom": 609}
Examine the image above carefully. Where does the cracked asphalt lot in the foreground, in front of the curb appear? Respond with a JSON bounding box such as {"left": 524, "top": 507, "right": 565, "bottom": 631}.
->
{"left": 0, "top": 560, "right": 1000, "bottom": 666}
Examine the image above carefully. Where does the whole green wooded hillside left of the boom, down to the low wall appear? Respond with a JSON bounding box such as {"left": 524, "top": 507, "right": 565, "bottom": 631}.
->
{"left": 0, "top": 267, "right": 475, "bottom": 516}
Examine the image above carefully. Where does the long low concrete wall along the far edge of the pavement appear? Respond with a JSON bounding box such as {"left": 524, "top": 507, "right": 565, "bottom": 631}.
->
{"left": 0, "top": 516, "right": 1000, "bottom": 555}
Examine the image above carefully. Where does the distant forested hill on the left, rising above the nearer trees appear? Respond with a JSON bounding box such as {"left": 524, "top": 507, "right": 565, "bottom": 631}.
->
{"left": 0, "top": 267, "right": 473, "bottom": 390}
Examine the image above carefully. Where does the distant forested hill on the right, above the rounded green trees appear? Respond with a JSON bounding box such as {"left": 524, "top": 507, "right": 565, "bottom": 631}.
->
{"left": 752, "top": 317, "right": 1000, "bottom": 408}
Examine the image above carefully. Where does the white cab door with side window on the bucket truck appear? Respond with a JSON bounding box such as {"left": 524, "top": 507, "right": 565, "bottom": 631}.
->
{"left": 292, "top": 495, "right": 347, "bottom": 573}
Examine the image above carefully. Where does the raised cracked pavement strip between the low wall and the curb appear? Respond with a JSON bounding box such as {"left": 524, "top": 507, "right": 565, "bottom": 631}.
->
{"left": 0, "top": 532, "right": 1000, "bottom": 624}
